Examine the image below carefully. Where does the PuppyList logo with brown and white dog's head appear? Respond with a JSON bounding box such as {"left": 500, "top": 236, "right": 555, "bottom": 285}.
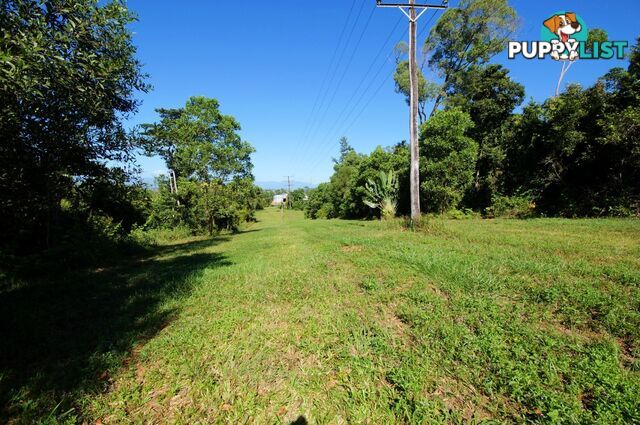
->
{"left": 508, "top": 11, "right": 629, "bottom": 62}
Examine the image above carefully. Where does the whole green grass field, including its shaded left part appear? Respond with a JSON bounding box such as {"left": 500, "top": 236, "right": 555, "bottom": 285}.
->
{"left": 0, "top": 209, "right": 640, "bottom": 424}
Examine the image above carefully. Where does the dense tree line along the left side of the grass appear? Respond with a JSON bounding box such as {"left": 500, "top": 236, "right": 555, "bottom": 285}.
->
{"left": 0, "top": 0, "right": 260, "bottom": 261}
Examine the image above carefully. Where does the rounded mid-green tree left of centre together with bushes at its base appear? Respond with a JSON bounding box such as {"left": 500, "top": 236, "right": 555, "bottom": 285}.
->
{"left": 141, "top": 97, "right": 260, "bottom": 235}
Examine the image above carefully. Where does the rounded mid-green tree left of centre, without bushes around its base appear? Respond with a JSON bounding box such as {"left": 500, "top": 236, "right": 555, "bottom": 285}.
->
{"left": 141, "top": 97, "right": 254, "bottom": 234}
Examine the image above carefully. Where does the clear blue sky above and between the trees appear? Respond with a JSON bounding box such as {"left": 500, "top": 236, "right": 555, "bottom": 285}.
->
{"left": 128, "top": 0, "right": 640, "bottom": 184}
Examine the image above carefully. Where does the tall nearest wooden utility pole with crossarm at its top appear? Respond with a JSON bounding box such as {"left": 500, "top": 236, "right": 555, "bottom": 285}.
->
{"left": 376, "top": 0, "right": 449, "bottom": 220}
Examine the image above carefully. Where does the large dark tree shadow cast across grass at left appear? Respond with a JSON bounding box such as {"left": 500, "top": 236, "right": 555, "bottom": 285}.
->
{"left": 0, "top": 238, "right": 230, "bottom": 423}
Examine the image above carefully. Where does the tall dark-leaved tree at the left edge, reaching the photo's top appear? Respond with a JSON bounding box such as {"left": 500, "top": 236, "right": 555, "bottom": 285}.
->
{"left": 0, "top": 0, "right": 149, "bottom": 245}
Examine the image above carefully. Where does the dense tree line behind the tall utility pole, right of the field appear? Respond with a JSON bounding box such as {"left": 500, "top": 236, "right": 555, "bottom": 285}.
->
{"left": 307, "top": 0, "right": 640, "bottom": 218}
